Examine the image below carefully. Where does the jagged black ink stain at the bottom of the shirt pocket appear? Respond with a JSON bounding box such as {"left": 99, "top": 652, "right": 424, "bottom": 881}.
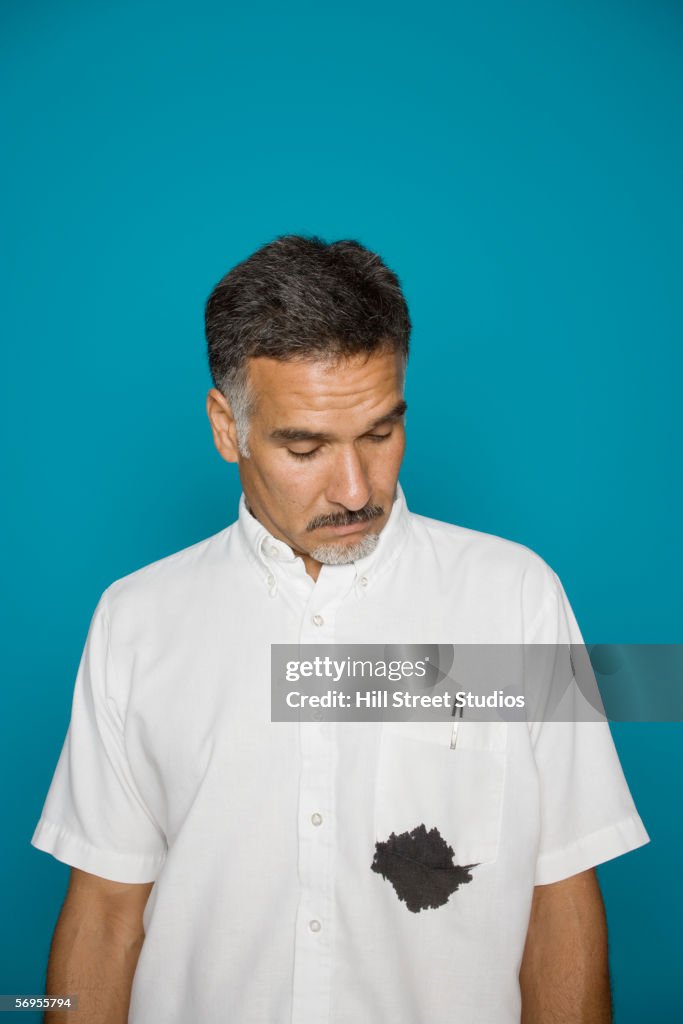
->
{"left": 371, "top": 825, "right": 477, "bottom": 913}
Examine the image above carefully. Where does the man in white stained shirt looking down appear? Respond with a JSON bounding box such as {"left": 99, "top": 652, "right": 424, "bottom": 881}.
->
{"left": 32, "top": 236, "right": 647, "bottom": 1024}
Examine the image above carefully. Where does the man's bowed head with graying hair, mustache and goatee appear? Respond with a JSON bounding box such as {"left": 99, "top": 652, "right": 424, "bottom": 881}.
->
{"left": 206, "top": 236, "right": 411, "bottom": 575}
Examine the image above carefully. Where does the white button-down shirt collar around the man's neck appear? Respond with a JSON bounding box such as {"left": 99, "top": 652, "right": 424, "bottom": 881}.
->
{"left": 237, "top": 481, "right": 410, "bottom": 587}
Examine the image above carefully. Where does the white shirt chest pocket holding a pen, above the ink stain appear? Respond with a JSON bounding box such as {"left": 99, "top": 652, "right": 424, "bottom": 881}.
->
{"left": 374, "top": 722, "right": 507, "bottom": 864}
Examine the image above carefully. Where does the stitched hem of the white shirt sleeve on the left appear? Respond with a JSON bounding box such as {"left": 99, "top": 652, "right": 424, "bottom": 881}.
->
{"left": 31, "top": 818, "right": 166, "bottom": 883}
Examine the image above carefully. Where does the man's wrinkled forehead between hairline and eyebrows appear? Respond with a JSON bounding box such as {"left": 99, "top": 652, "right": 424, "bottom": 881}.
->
{"left": 248, "top": 352, "right": 403, "bottom": 427}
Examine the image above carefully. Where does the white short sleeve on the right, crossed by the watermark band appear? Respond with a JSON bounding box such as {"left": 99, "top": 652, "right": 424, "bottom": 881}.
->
{"left": 529, "top": 569, "right": 649, "bottom": 885}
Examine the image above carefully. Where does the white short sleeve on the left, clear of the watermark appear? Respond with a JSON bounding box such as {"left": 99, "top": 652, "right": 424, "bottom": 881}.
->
{"left": 31, "top": 591, "right": 167, "bottom": 883}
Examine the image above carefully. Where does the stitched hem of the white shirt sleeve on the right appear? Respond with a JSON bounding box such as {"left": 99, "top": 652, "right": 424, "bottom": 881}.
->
{"left": 533, "top": 814, "right": 650, "bottom": 886}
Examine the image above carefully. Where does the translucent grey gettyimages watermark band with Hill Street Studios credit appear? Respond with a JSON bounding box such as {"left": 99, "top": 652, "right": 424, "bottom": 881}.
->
{"left": 271, "top": 644, "right": 683, "bottom": 722}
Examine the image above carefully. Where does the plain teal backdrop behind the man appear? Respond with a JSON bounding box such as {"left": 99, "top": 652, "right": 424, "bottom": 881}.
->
{"left": 0, "top": 0, "right": 683, "bottom": 1024}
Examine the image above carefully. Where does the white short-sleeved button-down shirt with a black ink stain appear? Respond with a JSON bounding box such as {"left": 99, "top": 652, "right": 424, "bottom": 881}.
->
{"left": 32, "top": 487, "right": 648, "bottom": 1024}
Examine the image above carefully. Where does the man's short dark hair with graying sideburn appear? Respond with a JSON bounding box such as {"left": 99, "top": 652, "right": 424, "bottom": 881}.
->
{"left": 200, "top": 234, "right": 411, "bottom": 456}
